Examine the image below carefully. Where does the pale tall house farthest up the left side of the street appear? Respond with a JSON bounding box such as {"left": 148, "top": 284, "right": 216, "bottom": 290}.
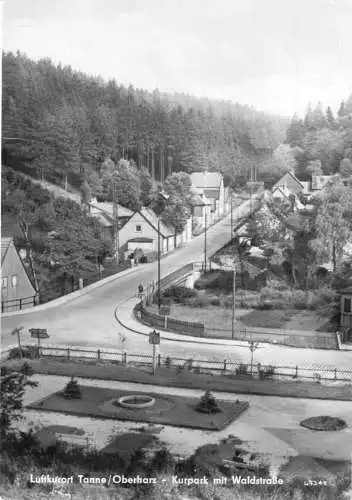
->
{"left": 191, "top": 171, "right": 225, "bottom": 218}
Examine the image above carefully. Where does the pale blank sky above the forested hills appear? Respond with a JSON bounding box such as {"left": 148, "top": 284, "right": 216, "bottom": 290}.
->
{"left": 2, "top": 0, "right": 352, "bottom": 116}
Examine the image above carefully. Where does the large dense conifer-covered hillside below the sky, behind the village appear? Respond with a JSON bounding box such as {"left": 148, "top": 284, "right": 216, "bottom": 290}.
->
{"left": 2, "top": 52, "right": 288, "bottom": 190}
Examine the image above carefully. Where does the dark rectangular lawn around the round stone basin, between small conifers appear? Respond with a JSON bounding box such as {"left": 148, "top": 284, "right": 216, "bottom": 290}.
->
{"left": 27, "top": 386, "right": 248, "bottom": 431}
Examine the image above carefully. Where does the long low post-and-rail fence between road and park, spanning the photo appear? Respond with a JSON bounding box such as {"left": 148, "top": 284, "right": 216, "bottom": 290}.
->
{"left": 1, "top": 345, "right": 352, "bottom": 383}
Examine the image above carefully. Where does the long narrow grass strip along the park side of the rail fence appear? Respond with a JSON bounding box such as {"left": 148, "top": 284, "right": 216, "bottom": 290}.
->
{"left": 7, "top": 358, "right": 352, "bottom": 401}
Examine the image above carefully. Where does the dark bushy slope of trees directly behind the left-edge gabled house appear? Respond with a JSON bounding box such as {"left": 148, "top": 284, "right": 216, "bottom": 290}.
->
{"left": 1, "top": 167, "right": 112, "bottom": 302}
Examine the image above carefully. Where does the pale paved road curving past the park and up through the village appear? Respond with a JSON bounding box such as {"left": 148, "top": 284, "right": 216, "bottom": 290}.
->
{"left": 2, "top": 198, "right": 352, "bottom": 369}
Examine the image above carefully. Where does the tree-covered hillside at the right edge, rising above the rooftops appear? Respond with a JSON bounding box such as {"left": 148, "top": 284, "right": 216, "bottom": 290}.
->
{"left": 286, "top": 94, "right": 352, "bottom": 180}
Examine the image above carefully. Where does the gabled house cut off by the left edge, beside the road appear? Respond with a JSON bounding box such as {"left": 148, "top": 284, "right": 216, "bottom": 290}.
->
{"left": 1, "top": 238, "right": 37, "bottom": 312}
